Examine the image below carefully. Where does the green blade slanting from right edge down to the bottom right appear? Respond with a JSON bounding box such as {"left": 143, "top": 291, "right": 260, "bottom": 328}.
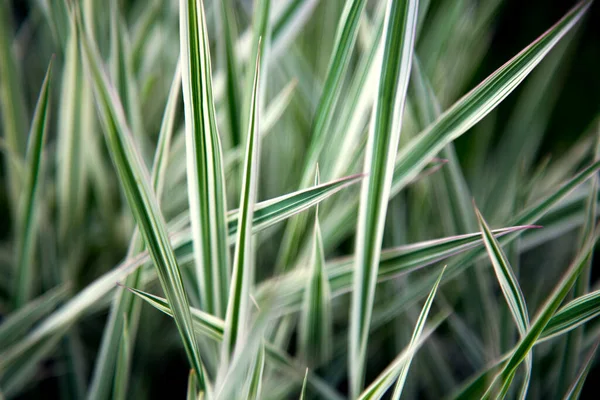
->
{"left": 483, "top": 230, "right": 600, "bottom": 399}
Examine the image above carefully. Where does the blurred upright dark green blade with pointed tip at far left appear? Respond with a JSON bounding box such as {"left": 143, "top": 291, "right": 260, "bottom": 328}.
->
{"left": 14, "top": 60, "right": 52, "bottom": 308}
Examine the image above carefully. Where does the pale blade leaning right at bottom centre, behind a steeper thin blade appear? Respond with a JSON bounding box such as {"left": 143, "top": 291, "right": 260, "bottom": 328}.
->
{"left": 357, "top": 318, "right": 443, "bottom": 400}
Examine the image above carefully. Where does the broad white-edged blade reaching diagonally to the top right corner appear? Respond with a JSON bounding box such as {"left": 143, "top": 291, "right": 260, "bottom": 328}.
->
{"left": 323, "top": 0, "right": 590, "bottom": 253}
